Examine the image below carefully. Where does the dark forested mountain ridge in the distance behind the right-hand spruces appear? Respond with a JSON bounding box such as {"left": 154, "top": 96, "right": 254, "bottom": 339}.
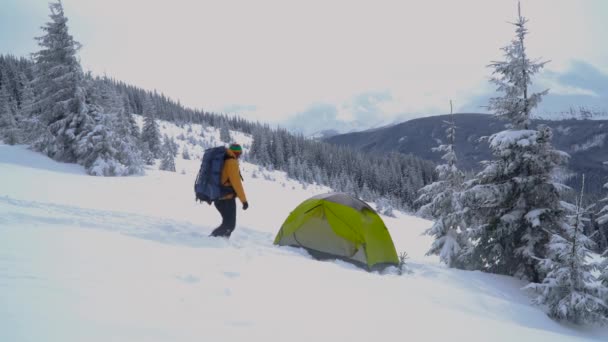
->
{"left": 325, "top": 113, "right": 608, "bottom": 192}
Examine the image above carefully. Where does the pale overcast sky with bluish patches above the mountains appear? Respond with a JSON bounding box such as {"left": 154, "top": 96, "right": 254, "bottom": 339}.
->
{"left": 0, "top": 0, "right": 608, "bottom": 131}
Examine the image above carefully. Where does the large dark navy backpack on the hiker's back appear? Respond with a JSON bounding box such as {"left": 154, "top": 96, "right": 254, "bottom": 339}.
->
{"left": 194, "top": 146, "right": 234, "bottom": 204}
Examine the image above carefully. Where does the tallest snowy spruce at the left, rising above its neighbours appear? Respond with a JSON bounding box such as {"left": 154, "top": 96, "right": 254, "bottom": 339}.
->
{"left": 33, "top": 2, "right": 92, "bottom": 162}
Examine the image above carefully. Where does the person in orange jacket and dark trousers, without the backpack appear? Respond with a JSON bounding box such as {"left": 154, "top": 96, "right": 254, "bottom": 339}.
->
{"left": 211, "top": 144, "right": 249, "bottom": 238}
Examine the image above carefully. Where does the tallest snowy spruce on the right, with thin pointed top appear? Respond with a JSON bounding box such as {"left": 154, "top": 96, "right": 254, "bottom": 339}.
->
{"left": 461, "top": 6, "right": 568, "bottom": 283}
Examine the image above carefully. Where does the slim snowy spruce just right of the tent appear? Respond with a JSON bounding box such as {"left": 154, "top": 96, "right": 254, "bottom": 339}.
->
{"left": 417, "top": 104, "right": 467, "bottom": 267}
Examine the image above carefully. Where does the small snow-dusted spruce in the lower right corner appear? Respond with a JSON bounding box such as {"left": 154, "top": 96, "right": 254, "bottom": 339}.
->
{"left": 525, "top": 176, "right": 608, "bottom": 324}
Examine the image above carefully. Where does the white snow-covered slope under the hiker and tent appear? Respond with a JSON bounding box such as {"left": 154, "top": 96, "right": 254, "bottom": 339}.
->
{"left": 0, "top": 119, "right": 608, "bottom": 342}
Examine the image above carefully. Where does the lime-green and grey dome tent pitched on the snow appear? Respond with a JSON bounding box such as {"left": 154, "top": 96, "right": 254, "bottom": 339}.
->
{"left": 274, "top": 193, "right": 399, "bottom": 269}
